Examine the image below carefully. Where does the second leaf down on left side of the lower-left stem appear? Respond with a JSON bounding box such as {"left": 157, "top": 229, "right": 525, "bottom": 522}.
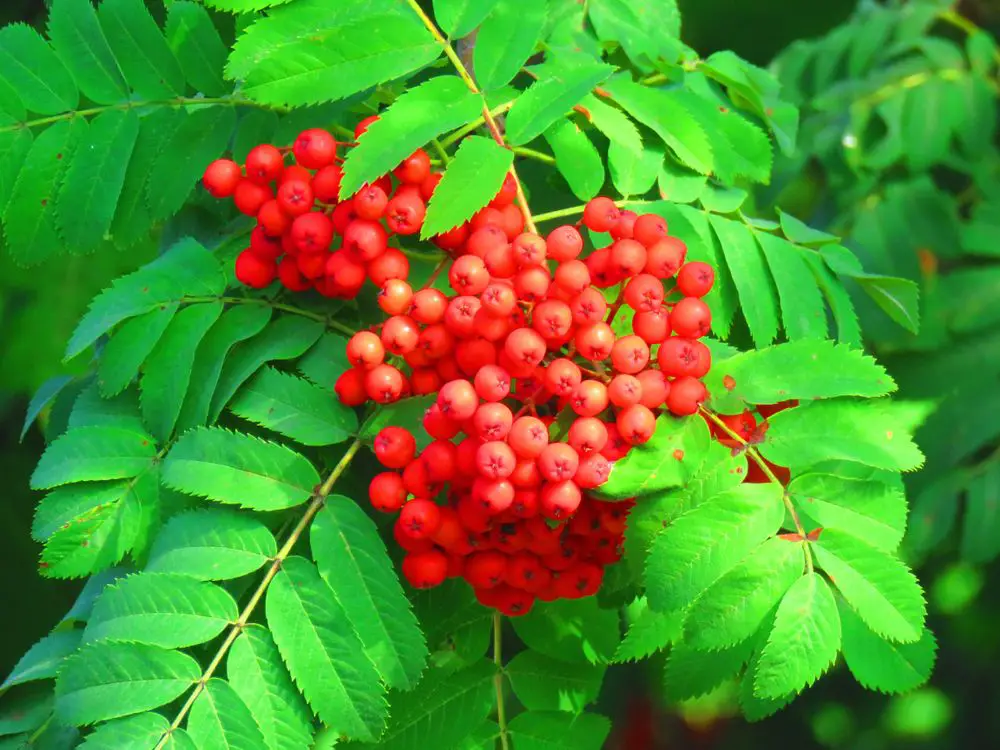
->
{"left": 145, "top": 508, "right": 277, "bottom": 581}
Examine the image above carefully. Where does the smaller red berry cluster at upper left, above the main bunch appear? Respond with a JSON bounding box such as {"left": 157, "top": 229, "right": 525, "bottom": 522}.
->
{"left": 202, "top": 116, "right": 436, "bottom": 299}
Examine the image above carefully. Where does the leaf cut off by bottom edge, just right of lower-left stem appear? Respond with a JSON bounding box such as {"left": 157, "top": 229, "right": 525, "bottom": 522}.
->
{"left": 187, "top": 677, "right": 268, "bottom": 750}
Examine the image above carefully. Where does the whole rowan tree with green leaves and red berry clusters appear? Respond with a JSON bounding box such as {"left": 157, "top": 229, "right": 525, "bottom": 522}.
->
{"left": 0, "top": 0, "right": 972, "bottom": 750}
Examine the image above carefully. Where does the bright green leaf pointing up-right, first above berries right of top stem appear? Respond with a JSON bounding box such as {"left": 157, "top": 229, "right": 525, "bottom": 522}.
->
{"left": 504, "top": 60, "right": 614, "bottom": 146}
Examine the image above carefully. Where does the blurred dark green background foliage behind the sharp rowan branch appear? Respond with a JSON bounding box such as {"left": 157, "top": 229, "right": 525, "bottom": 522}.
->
{"left": 0, "top": 0, "right": 1000, "bottom": 750}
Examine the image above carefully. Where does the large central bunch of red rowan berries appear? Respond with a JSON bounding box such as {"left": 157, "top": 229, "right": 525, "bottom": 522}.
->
{"left": 336, "top": 192, "right": 714, "bottom": 615}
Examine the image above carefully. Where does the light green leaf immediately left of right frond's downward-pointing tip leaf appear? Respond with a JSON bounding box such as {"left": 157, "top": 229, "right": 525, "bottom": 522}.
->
{"left": 684, "top": 539, "right": 805, "bottom": 651}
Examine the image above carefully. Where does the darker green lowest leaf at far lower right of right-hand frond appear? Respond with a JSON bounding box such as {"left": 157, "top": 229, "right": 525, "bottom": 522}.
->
{"left": 840, "top": 603, "right": 937, "bottom": 693}
